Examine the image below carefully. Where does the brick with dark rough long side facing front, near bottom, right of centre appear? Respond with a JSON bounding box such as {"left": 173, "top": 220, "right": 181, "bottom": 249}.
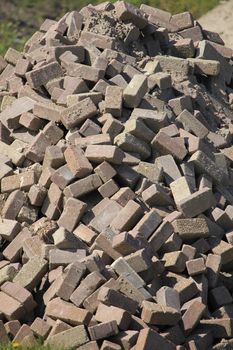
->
{"left": 141, "top": 300, "right": 181, "bottom": 326}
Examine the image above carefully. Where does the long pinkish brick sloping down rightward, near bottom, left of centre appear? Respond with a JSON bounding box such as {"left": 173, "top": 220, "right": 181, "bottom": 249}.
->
{"left": 45, "top": 298, "right": 92, "bottom": 326}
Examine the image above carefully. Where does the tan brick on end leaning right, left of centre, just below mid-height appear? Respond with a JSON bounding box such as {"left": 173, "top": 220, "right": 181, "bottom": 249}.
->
{"left": 58, "top": 198, "right": 87, "bottom": 232}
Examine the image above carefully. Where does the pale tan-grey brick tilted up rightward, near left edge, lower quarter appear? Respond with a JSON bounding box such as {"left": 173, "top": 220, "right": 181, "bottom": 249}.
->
{"left": 13, "top": 257, "right": 47, "bottom": 291}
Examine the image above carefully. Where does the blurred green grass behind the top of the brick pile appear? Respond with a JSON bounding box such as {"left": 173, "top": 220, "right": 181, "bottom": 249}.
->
{"left": 0, "top": 0, "right": 220, "bottom": 54}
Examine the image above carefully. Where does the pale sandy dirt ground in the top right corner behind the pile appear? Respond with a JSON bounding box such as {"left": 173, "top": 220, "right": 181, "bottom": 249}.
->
{"left": 198, "top": 0, "right": 233, "bottom": 48}
